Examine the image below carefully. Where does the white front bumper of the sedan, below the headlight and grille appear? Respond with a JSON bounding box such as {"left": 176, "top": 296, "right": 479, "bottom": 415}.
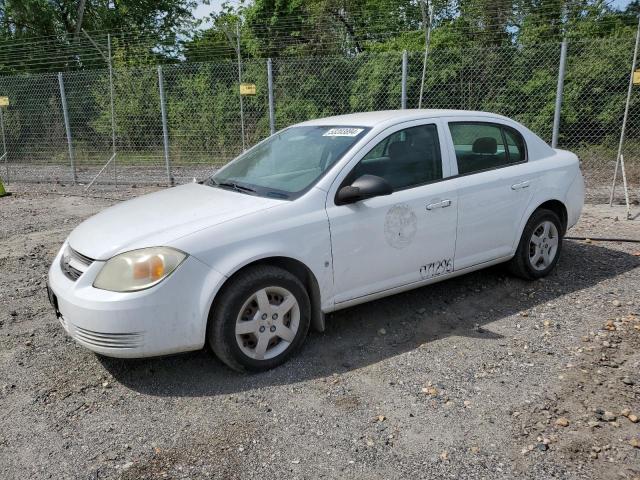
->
{"left": 48, "top": 247, "right": 224, "bottom": 358}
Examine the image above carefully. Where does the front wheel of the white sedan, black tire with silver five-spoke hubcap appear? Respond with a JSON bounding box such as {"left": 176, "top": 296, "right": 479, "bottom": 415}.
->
{"left": 207, "top": 265, "right": 311, "bottom": 372}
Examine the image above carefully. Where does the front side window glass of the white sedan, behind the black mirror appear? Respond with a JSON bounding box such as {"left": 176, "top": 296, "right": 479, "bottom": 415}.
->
{"left": 351, "top": 125, "right": 442, "bottom": 190}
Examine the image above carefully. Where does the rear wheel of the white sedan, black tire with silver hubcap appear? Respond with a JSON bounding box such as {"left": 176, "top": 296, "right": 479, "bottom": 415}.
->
{"left": 508, "top": 208, "right": 563, "bottom": 280}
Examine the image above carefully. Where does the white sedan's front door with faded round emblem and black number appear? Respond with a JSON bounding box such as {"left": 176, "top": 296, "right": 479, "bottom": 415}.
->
{"left": 327, "top": 120, "right": 458, "bottom": 303}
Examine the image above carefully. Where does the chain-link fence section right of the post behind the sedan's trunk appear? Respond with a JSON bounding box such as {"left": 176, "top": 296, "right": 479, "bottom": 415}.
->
{"left": 558, "top": 38, "right": 640, "bottom": 203}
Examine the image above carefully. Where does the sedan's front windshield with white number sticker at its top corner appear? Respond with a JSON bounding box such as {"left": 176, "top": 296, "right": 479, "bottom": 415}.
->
{"left": 208, "top": 126, "right": 368, "bottom": 198}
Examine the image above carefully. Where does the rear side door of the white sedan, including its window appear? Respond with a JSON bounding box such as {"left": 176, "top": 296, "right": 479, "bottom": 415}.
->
{"left": 446, "top": 118, "right": 535, "bottom": 270}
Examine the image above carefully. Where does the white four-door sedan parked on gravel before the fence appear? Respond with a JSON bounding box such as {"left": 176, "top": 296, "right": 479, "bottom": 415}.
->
{"left": 49, "top": 110, "right": 584, "bottom": 371}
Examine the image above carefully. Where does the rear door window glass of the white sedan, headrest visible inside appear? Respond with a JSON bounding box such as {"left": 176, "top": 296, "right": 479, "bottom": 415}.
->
{"left": 449, "top": 123, "right": 526, "bottom": 174}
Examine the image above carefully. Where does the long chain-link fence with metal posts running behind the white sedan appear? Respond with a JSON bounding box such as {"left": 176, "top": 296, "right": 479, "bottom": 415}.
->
{"left": 0, "top": 38, "right": 640, "bottom": 201}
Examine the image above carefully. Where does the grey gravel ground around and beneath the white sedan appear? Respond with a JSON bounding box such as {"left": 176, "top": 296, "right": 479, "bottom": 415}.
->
{"left": 0, "top": 184, "right": 640, "bottom": 479}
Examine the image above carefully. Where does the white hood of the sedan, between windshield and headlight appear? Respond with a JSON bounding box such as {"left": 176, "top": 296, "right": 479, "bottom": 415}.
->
{"left": 69, "top": 183, "right": 285, "bottom": 260}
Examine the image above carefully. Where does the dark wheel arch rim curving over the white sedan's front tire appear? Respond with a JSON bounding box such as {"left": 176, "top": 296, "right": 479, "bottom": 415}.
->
{"left": 209, "top": 255, "right": 325, "bottom": 332}
